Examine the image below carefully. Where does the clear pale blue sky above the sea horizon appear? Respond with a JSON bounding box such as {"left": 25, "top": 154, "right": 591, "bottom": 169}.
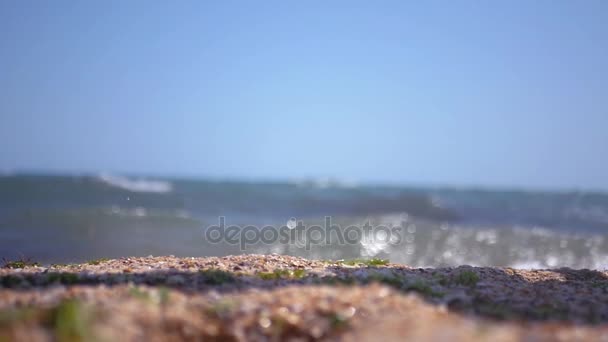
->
{"left": 0, "top": 0, "right": 608, "bottom": 189}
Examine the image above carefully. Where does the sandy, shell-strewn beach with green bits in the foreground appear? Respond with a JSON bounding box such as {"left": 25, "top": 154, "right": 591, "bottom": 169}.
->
{"left": 0, "top": 254, "right": 608, "bottom": 341}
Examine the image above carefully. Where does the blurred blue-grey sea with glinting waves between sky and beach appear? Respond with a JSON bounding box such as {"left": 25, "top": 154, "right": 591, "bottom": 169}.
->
{"left": 0, "top": 174, "right": 608, "bottom": 269}
